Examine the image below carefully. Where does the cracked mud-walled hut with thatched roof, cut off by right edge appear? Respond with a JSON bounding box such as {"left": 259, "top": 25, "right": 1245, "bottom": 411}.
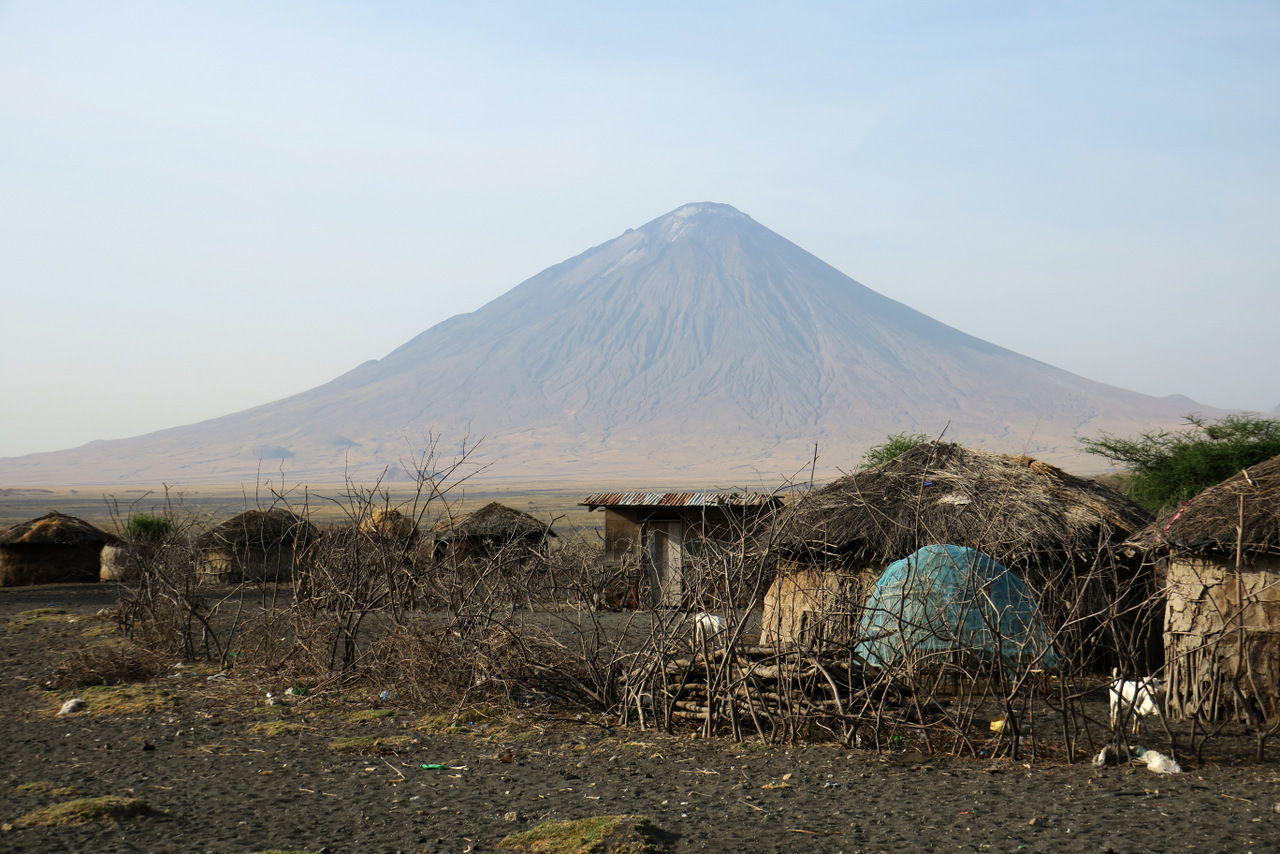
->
{"left": 1134, "top": 457, "right": 1280, "bottom": 722}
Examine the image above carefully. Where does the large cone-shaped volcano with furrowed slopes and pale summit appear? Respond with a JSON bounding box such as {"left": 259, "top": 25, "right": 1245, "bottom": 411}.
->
{"left": 0, "top": 198, "right": 1189, "bottom": 485}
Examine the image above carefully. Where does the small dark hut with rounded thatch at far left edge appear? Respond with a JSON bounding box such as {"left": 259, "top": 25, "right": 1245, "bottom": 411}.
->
{"left": 0, "top": 511, "right": 118, "bottom": 586}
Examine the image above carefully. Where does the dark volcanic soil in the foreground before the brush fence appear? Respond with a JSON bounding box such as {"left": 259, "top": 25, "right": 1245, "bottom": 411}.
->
{"left": 0, "top": 585, "right": 1280, "bottom": 854}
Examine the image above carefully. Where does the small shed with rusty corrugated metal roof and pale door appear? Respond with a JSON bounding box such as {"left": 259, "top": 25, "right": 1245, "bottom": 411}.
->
{"left": 580, "top": 492, "right": 782, "bottom": 608}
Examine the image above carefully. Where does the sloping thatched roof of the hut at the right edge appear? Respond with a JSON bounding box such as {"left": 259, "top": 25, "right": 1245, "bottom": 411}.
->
{"left": 1130, "top": 457, "right": 1280, "bottom": 554}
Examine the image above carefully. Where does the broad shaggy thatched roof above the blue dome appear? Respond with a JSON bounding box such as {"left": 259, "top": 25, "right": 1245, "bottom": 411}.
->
{"left": 780, "top": 442, "right": 1151, "bottom": 570}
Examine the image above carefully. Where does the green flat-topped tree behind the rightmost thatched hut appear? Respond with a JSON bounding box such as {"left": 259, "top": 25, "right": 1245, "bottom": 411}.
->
{"left": 1080, "top": 415, "right": 1280, "bottom": 510}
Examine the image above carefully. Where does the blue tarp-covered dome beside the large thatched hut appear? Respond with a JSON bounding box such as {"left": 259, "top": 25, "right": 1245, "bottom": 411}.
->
{"left": 856, "top": 545, "right": 1057, "bottom": 670}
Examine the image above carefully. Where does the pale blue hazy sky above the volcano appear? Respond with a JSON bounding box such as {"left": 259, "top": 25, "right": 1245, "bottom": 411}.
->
{"left": 0, "top": 0, "right": 1280, "bottom": 456}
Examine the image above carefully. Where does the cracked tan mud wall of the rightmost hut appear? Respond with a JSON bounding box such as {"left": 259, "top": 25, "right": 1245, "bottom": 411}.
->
{"left": 1165, "top": 557, "right": 1280, "bottom": 721}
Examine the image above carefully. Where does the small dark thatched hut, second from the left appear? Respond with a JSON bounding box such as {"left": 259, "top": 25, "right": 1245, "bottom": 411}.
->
{"left": 196, "top": 507, "right": 319, "bottom": 583}
